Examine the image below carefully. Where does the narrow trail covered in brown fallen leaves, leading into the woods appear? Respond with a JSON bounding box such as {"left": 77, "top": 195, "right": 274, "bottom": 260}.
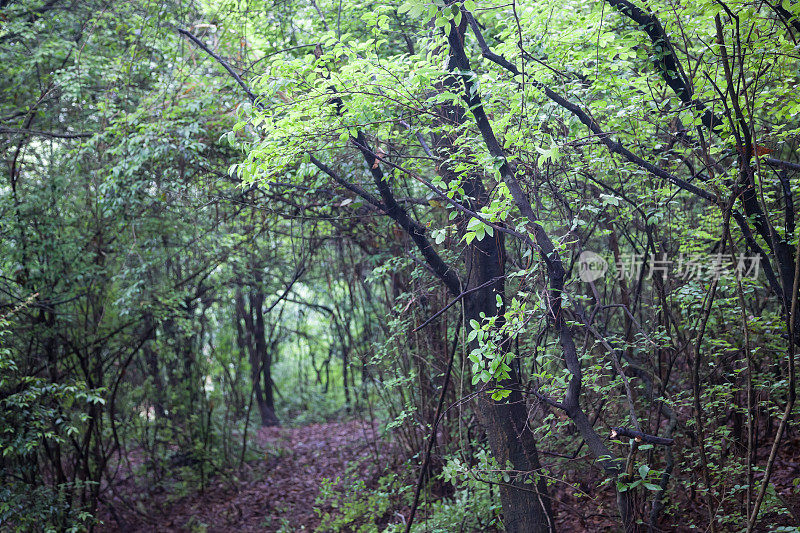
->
{"left": 99, "top": 421, "right": 377, "bottom": 533}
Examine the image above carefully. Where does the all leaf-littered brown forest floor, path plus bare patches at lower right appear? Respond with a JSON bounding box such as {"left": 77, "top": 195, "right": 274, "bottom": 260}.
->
{"left": 98, "top": 421, "right": 800, "bottom": 533}
